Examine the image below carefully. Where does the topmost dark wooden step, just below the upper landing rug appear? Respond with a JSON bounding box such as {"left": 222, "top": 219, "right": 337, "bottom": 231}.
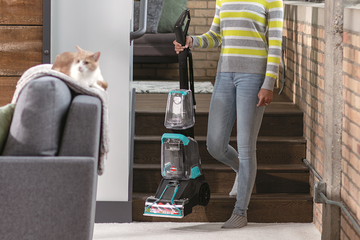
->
{"left": 135, "top": 94, "right": 303, "bottom": 136}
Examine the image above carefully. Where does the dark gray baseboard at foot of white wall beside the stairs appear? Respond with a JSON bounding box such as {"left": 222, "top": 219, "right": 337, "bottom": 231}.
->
{"left": 95, "top": 201, "right": 132, "bottom": 223}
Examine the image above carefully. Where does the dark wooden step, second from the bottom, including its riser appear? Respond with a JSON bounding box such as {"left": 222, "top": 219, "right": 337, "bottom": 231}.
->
{"left": 133, "top": 164, "right": 310, "bottom": 194}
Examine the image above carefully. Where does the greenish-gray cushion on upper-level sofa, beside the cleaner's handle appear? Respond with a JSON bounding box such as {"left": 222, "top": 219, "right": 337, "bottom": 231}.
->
{"left": 157, "top": 0, "right": 188, "bottom": 33}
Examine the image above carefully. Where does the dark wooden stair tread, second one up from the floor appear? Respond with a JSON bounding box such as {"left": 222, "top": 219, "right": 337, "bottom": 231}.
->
{"left": 133, "top": 163, "right": 309, "bottom": 171}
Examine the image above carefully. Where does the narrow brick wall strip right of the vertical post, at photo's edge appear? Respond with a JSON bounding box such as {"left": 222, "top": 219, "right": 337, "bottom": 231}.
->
{"left": 341, "top": 8, "right": 360, "bottom": 240}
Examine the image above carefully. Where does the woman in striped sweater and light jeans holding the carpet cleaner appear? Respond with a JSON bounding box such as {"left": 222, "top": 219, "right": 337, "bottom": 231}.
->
{"left": 174, "top": 0, "right": 283, "bottom": 228}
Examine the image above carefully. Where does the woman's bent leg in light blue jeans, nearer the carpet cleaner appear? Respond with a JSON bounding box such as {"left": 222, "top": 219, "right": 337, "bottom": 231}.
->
{"left": 207, "top": 73, "right": 239, "bottom": 171}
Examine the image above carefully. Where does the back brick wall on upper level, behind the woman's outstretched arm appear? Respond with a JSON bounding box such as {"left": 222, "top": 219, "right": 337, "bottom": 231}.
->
{"left": 134, "top": 0, "right": 220, "bottom": 81}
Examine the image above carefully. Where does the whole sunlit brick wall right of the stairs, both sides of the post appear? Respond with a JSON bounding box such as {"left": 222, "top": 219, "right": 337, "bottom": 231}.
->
{"left": 284, "top": 2, "right": 360, "bottom": 240}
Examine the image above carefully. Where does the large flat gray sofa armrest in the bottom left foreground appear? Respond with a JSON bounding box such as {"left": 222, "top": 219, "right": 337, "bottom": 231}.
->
{"left": 0, "top": 156, "right": 97, "bottom": 239}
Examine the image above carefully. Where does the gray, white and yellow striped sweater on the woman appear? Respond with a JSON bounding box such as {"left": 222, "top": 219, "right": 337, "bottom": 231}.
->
{"left": 192, "top": 0, "right": 283, "bottom": 91}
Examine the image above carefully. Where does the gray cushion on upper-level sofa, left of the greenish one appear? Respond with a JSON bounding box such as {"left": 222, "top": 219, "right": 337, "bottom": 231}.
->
{"left": 134, "top": 0, "right": 164, "bottom": 33}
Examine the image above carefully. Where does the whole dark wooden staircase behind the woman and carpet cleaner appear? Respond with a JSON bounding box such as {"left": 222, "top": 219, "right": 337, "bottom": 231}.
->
{"left": 132, "top": 88, "right": 313, "bottom": 223}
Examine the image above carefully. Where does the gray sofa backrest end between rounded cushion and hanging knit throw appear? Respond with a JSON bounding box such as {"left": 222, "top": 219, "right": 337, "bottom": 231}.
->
{"left": 58, "top": 95, "right": 101, "bottom": 158}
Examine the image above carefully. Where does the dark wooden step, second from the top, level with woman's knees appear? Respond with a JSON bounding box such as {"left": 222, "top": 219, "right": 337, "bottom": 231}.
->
{"left": 134, "top": 136, "right": 306, "bottom": 164}
